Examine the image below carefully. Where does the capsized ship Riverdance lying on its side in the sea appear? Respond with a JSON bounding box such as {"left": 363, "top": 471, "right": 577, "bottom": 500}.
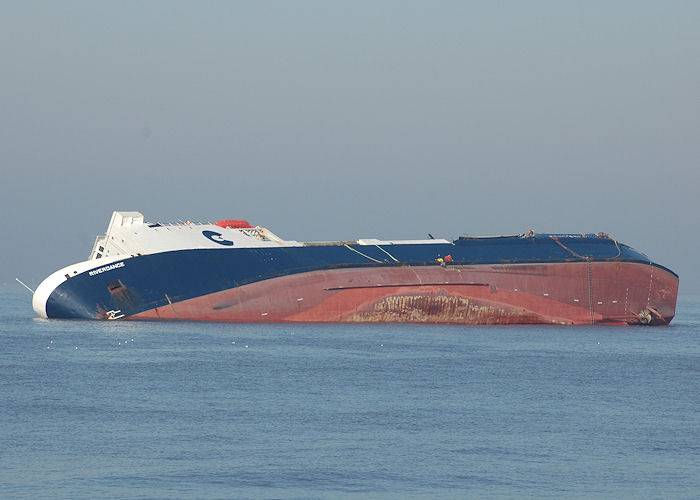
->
{"left": 33, "top": 211, "right": 678, "bottom": 325}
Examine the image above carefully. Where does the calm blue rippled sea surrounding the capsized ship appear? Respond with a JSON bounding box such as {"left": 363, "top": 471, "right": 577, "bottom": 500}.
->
{"left": 0, "top": 284, "right": 700, "bottom": 499}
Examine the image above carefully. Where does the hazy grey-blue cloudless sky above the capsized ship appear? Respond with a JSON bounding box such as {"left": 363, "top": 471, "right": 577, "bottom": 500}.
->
{"left": 0, "top": 0, "right": 700, "bottom": 294}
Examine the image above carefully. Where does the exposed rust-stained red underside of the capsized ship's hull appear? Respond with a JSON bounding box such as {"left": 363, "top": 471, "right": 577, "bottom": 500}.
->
{"left": 132, "top": 262, "right": 678, "bottom": 325}
